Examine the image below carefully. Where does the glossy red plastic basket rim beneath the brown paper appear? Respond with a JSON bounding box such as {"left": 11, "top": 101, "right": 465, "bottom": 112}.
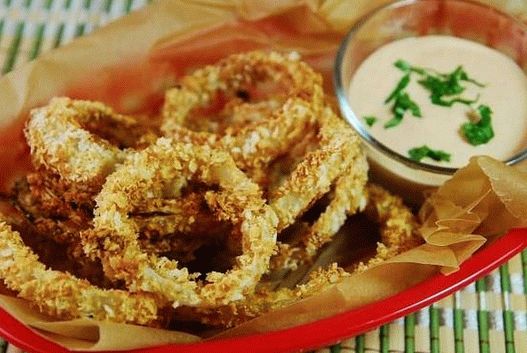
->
{"left": 0, "top": 228, "right": 527, "bottom": 353}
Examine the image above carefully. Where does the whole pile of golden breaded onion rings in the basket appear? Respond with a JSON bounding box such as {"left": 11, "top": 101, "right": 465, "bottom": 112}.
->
{"left": 0, "top": 51, "right": 421, "bottom": 327}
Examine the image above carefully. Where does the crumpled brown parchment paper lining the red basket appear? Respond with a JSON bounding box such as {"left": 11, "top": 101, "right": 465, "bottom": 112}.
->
{"left": 0, "top": 0, "right": 527, "bottom": 350}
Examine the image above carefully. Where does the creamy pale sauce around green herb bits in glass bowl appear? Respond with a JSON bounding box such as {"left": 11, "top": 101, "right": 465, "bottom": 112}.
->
{"left": 349, "top": 36, "right": 527, "bottom": 167}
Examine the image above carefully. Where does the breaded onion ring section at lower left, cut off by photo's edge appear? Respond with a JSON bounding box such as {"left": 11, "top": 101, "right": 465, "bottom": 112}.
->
{"left": 0, "top": 220, "right": 158, "bottom": 325}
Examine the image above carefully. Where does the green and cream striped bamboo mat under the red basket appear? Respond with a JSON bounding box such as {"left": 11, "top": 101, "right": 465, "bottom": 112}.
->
{"left": 0, "top": 0, "right": 527, "bottom": 353}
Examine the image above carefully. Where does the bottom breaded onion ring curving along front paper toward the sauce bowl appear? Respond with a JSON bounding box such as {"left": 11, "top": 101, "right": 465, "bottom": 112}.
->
{"left": 178, "top": 184, "right": 422, "bottom": 327}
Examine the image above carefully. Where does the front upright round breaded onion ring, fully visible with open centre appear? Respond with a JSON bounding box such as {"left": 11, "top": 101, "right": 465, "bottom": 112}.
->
{"left": 81, "top": 138, "right": 276, "bottom": 307}
